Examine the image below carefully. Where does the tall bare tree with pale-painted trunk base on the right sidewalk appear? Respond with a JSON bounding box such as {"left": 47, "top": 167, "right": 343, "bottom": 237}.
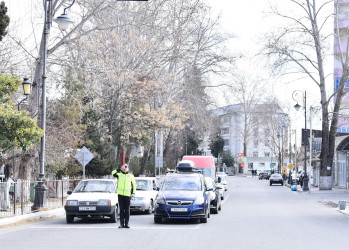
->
{"left": 264, "top": 0, "right": 349, "bottom": 190}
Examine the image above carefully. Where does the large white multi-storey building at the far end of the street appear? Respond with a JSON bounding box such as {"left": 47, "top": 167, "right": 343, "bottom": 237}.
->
{"left": 199, "top": 104, "right": 290, "bottom": 174}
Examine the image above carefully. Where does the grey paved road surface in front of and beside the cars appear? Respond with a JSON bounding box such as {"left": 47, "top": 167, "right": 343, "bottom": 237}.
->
{"left": 0, "top": 177, "right": 349, "bottom": 250}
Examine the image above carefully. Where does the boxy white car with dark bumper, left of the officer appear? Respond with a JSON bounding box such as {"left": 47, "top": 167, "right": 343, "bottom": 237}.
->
{"left": 64, "top": 179, "right": 118, "bottom": 223}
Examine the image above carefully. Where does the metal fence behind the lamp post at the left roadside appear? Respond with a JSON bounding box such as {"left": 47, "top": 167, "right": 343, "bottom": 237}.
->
{"left": 0, "top": 179, "right": 80, "bottom": 217}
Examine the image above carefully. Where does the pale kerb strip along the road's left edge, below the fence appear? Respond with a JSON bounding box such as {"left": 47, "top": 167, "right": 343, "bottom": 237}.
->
{"left": 0, "top": 208, "right": 65, "bottom": 227}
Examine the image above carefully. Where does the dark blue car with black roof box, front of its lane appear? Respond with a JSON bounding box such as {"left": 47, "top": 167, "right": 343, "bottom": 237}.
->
{"left": 154, "top": 172, "right": 210, "bottom": 223}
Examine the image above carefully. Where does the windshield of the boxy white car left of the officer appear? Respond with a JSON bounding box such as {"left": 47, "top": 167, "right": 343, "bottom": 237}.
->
{"left": 74, "top": 180, "right": 115, "bottom": 193}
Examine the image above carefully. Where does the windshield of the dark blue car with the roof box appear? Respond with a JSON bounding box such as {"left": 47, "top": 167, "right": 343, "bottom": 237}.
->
{"left": 162, "top": 175, "right": 201, "bottom": 191}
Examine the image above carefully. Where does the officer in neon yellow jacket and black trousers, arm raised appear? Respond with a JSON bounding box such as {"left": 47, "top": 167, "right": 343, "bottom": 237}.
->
{"left": 111, "top": 164, "right": 136, "bottom": 228}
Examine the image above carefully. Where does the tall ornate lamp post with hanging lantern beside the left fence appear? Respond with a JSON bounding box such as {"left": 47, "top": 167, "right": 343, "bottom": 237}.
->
{"left": 32, "top": 0, "right": 75, "bottom": 210}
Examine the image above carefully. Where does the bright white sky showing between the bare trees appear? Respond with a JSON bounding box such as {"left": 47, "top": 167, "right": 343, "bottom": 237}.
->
{"left": 4, "top": 0, "right": 328, "bottom": 133}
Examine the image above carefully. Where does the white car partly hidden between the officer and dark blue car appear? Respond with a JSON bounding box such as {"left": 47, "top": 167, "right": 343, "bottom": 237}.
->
{"left": 130, "top": 177, "right": 159, "bottom": 214}
